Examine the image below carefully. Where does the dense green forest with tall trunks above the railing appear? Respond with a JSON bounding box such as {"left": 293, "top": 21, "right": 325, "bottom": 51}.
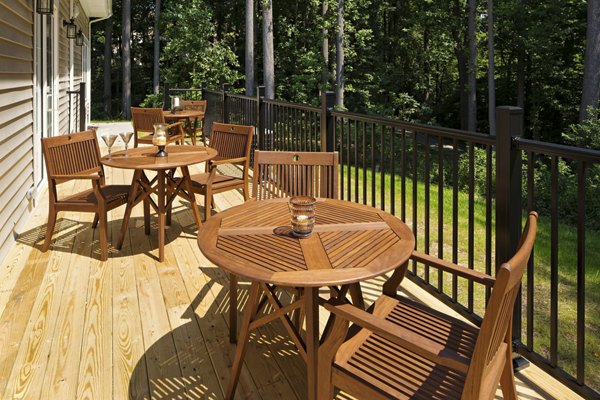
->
{"left": 91, "top": 0, "right": 600, "bottom": 147}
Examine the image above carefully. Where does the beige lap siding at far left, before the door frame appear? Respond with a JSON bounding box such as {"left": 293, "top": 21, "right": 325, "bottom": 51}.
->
{"left": 0, "top": 0, "right": 34, "bottom": 260}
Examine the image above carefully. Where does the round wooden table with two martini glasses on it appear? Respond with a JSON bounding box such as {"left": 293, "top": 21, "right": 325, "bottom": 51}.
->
{"left": 101, "top": 145, "right": 217, "bottom": 262}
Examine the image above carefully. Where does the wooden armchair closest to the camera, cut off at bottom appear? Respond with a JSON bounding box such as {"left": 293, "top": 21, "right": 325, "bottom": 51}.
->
{"left": 318, "top": 212, "right": 537, "bottom": 400}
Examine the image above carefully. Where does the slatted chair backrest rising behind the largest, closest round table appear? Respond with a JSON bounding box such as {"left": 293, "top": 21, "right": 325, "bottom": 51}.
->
{"left": 252, "top": 151, "right": 338, "bottom": 200}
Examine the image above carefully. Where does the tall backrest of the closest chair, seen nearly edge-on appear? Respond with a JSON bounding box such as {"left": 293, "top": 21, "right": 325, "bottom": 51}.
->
{"left": 463, "top": 212, "right": 537, "bottom": 398}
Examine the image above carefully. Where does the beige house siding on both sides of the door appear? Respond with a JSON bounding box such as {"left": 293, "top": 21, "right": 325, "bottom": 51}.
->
{"left": 0, "top": 0, "right": 89, "bottom": 261}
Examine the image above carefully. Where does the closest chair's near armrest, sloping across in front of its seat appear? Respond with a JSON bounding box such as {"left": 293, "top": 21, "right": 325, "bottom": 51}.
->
{"left": 324, "top": 301, "right": 470, "bottom": 373}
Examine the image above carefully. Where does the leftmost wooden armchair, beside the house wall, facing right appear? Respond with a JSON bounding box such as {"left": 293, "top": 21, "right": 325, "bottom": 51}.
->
{"left": 42, "top": 131, "right": 131, "bottom": 261}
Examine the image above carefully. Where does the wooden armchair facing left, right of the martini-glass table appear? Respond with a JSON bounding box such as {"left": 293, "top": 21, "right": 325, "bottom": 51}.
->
{"left": 178, "top": 122, "right": 254, "bottom": 220}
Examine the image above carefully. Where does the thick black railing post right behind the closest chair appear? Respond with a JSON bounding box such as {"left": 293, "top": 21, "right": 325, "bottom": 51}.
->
{"left": 496, "top": 106, "right": 523, "bottom": 354}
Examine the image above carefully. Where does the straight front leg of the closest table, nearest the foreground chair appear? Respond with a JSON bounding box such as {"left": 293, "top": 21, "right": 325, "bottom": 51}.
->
{"left": 304, "top": 287, "right": 319, "bottom": 400}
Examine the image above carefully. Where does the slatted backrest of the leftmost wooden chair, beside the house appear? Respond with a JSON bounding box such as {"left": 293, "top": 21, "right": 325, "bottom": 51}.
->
{"left": 42, "top": 131, "right": 102, "bottom": 183}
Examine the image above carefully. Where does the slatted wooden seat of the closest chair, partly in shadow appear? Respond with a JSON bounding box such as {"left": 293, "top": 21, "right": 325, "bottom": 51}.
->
{"left": 332, "top": 296, "right": 479, "bottom": 400}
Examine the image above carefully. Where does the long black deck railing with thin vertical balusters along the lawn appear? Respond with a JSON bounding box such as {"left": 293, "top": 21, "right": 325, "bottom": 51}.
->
{"left": 163, "top": 83, "right": 600, "bottom": 398}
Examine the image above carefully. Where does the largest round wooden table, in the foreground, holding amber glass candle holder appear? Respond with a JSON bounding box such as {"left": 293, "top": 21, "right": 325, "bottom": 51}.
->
{"left": 198, "top": 199, "right": 415, "bottom": 400}
